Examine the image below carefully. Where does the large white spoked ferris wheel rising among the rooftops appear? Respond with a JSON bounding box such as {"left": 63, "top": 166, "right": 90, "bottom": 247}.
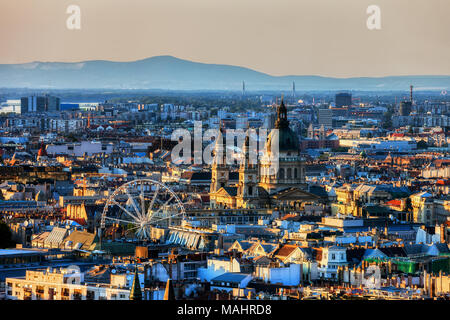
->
{"left": 100, "top": 179, "right": 185, "bottom": 239}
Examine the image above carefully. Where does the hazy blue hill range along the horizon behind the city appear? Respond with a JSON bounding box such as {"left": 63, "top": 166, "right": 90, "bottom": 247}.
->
{"left": 0, "top": 56, "right": 450, "bottom": 91}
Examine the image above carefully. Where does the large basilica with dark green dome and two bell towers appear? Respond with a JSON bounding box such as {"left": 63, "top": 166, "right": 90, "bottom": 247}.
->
{"left": 210, "top": 99, "right": 319, "bottom": 209}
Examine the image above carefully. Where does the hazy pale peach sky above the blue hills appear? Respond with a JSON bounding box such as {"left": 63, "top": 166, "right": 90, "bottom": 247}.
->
{"left": 0, "top": 0, "right": 450, "bottom": 77}
